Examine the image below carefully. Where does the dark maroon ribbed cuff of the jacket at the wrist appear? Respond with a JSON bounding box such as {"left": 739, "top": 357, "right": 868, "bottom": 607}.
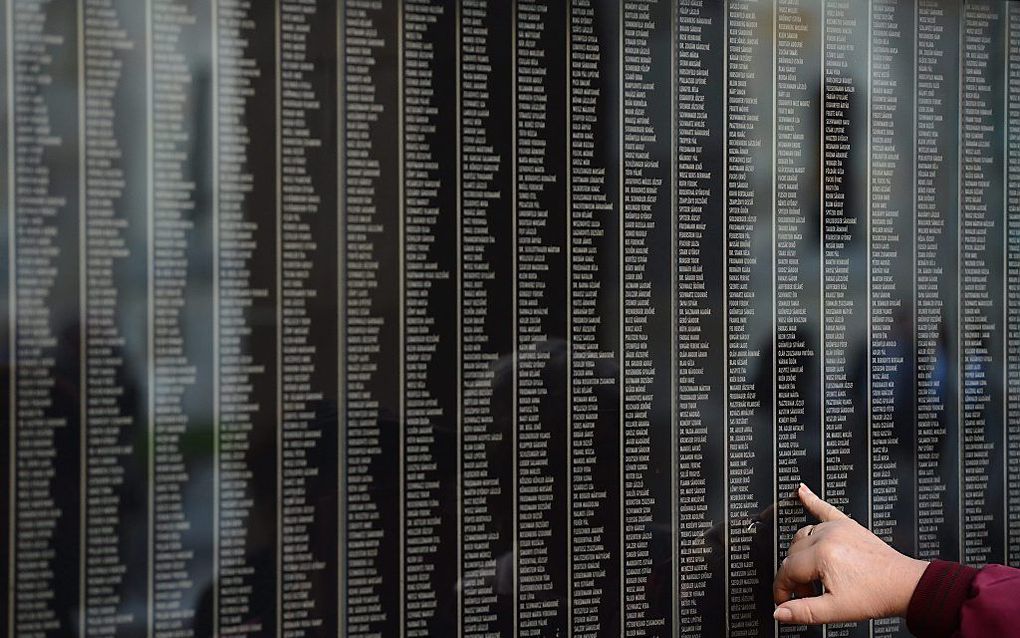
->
{"left": 907, "top": 560, "right": 977, "bottom": 638}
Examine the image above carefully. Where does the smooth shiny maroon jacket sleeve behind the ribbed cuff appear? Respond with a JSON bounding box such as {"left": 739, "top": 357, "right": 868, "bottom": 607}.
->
{"left": 960, "top": 565, "right": 1020, "bottom": 638}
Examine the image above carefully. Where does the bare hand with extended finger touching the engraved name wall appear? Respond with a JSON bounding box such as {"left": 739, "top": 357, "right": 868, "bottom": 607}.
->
{"left": 772, "top": 483, "right": 928, "bottom": 625}
